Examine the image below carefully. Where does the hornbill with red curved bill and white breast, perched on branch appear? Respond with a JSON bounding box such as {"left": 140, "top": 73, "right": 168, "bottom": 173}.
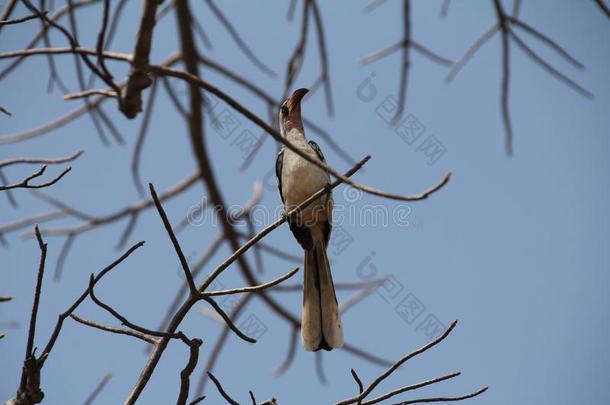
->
{"left": 275, "top": 89, "right": 343, "bottom": 351}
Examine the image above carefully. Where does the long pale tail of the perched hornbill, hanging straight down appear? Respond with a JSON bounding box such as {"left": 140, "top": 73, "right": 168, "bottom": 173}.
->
{"left": 301, "top": 242, "right": 343, "bottom": 351}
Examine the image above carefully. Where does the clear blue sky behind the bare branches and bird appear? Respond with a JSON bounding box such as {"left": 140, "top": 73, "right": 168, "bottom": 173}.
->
{"left": 0, "top": 0, "right": 610, "bottom": 404}
